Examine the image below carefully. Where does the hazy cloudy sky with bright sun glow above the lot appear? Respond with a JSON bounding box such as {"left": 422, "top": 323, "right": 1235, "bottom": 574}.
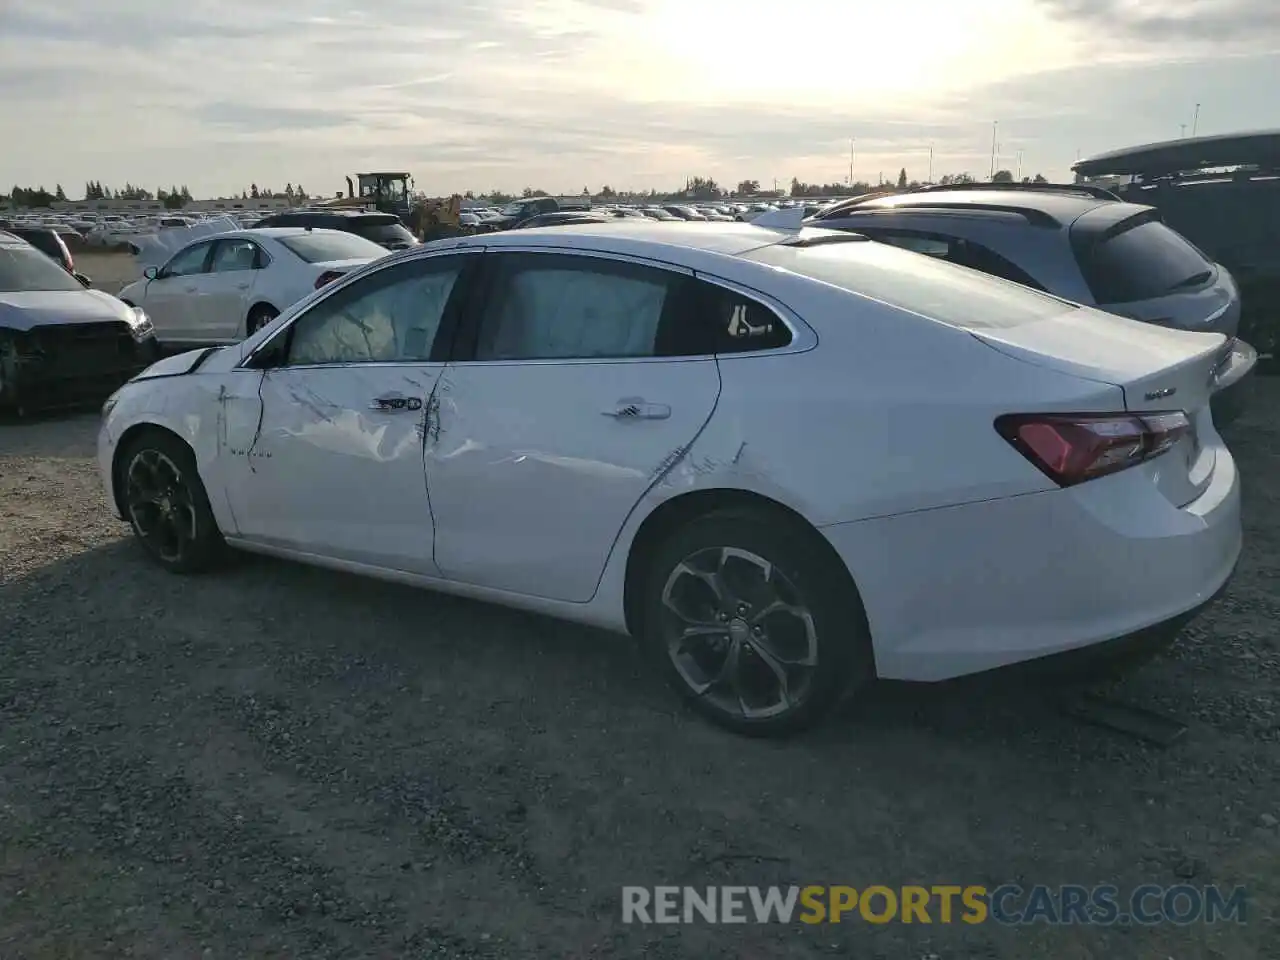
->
{"left": 0, "top": 0, "right": 1280, "bottom": 198}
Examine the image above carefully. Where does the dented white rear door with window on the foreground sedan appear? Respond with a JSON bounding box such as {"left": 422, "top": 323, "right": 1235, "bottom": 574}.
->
{"left": 425, "top": 248, "right": 721, "bottom": 603}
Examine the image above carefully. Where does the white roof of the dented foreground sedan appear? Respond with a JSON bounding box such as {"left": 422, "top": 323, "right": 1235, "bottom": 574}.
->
{"left": 463, "top": 218, "right": 849, "bottom": 259}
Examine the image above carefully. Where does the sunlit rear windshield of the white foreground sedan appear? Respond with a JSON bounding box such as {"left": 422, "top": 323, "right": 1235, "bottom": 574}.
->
{"left": 744, "top": 241, "right": 1078, "bottom": 330}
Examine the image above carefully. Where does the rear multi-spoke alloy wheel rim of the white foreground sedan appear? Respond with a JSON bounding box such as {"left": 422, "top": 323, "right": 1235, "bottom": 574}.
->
{"left": 662, "top": 547, "right": 818, "bottom": 719}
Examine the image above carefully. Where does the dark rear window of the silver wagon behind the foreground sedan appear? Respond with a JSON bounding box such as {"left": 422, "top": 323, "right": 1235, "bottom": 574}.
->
{"left": 1075, "top": 220, "right": 1213, "bottom": 303}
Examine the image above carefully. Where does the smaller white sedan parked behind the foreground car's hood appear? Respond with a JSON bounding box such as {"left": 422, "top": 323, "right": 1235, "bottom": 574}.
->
{"left": 118, "top": 227, "right": 387, "bottom": 344}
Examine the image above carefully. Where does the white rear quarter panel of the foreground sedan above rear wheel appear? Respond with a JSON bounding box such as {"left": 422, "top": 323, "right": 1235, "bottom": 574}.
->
{"left": 649, "top": 271, "right": 1124, "bottom": 526}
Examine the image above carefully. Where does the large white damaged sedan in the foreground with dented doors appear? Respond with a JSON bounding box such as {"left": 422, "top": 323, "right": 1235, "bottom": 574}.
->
{"left": 99, "top": 220, "right": 1240, "bottom": 733}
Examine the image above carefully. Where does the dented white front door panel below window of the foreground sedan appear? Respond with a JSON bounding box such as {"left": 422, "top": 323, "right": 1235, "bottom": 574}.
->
{"left": 229, "top": 364, "right": 443, "bottom": 575}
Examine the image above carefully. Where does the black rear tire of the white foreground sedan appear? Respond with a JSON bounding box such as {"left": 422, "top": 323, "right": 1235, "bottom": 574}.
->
{"left": 641, "top": 509, "right": 876, "bottom": 736}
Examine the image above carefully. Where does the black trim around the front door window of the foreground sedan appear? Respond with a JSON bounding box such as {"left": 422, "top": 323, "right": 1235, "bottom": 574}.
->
{"left": 237, "top": 247, "right": 484, "bottom": 371}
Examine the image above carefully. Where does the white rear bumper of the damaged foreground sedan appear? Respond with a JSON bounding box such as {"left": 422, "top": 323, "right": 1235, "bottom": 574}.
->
{"left": 822, "top": 435, "right": 1242, "bottom": 681}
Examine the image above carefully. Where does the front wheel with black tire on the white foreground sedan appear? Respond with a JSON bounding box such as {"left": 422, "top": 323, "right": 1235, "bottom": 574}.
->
{"left": 118, "top": 430, "right": 225, "bottom": 573}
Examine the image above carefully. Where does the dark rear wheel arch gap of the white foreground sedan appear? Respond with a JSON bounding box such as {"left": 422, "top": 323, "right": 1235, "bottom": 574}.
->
{"left": 622, "top": 488, "right": 865, "bottom": 636}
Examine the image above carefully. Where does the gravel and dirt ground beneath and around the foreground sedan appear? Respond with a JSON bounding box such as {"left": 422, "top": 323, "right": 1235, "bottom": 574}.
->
{"left": 0, "top": 380, "right": 1280, "bottom": 960}
